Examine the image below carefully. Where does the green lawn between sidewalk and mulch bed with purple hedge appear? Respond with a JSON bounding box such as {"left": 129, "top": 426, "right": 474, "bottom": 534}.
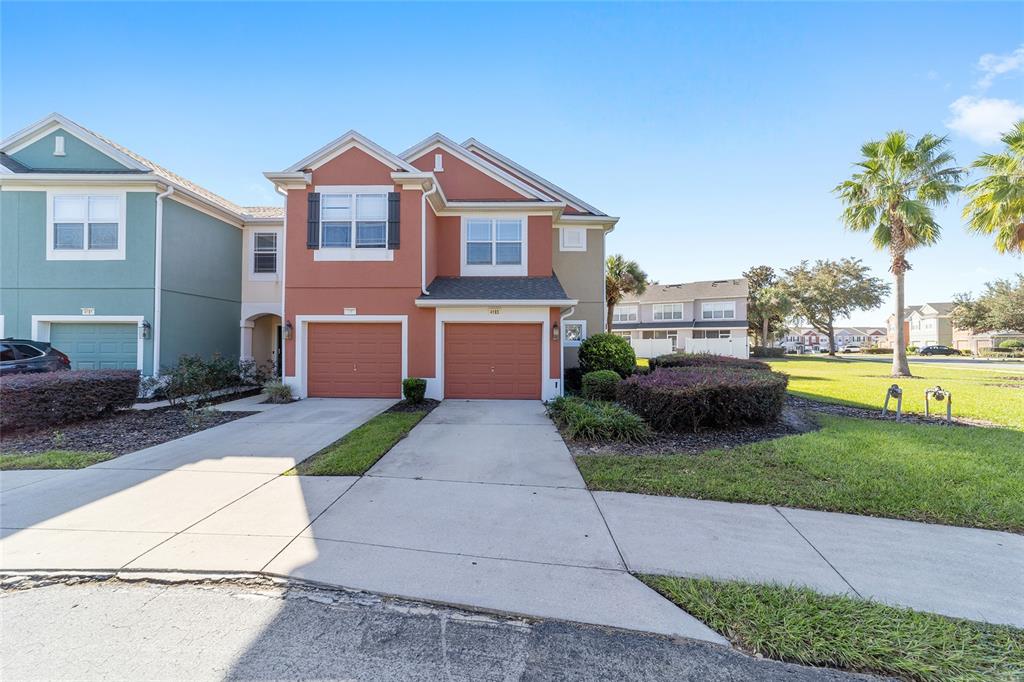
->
{"left": 577, "top": 416, "right": 1024, "bottom": 532}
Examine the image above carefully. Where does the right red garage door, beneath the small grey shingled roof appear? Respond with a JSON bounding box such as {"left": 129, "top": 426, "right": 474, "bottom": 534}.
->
{"left": 444, "top": 323, "right": 541, "bottom": 399}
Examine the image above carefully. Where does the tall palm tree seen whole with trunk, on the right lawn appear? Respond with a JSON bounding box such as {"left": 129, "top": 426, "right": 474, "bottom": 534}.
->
{"left": 834, "top": 130, "right": 964, "bottom": 377}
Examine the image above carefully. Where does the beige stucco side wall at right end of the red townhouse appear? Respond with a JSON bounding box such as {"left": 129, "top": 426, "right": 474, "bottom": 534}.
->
{"left": 551, "top": 228, "right": 604, "bottom": 368}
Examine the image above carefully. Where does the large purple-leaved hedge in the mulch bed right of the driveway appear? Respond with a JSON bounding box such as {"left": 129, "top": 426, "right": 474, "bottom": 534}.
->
{"left": 616, "top": 367, "right": 788, "bottom": 431}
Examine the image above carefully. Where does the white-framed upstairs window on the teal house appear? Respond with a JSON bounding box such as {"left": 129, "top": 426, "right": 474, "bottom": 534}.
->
{"left": 46, "top": 194, "right": 125, "bottom": 260}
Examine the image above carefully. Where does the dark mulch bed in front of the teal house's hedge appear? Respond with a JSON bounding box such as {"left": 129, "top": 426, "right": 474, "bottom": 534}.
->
{"left": 0, "top": 408, "right": 256, "bottom": 455}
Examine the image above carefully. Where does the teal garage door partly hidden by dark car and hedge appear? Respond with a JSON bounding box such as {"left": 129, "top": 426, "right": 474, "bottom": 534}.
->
{"left": 50, "top": 323, "right": 138, "bottom": 370}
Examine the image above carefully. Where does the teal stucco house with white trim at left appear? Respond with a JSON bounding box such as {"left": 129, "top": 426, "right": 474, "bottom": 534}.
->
{"left": 0, "top": 114, "right": 283, "bottom": 375}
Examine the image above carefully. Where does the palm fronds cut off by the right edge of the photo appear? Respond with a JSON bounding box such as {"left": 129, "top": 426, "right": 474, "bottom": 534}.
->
{"left": 964, "top": 120, "right": 1024, "bottom": 254}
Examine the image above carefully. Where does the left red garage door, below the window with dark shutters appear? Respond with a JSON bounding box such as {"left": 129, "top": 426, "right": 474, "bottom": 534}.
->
{"left": 306, "top": 323, "right": 401, "bottom": 397}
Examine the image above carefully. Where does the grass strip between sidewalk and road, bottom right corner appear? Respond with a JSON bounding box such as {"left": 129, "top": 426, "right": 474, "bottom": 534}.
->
{"left": 641, "top": 576, "right": 1024, "bottom": 681}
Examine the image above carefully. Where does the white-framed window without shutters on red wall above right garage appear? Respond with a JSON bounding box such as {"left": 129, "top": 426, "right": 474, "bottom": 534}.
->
{"left": 462, "top": 217, "right": 526, "bottom": 275}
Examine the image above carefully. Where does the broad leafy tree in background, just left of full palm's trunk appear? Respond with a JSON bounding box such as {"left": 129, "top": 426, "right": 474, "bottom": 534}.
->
{"left": 781, "top": 258, "right": 889, "bottom": 355}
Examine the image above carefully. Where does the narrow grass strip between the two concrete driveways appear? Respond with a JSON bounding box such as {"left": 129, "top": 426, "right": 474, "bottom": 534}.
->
{"left": 286, "top": 405, "right": 427, "bottom": 476}
